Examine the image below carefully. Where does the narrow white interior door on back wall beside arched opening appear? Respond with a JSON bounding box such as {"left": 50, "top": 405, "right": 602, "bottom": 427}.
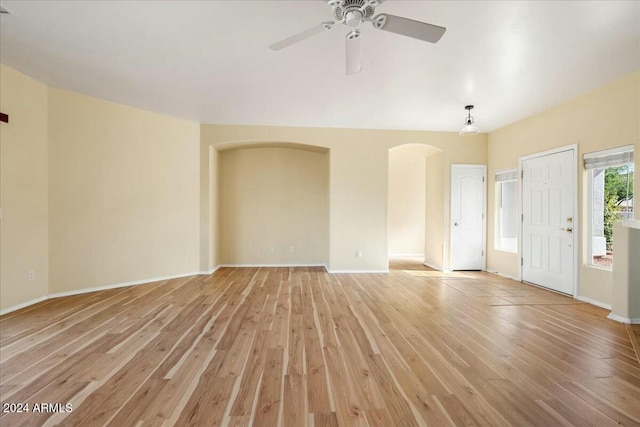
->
{"left": 449, "top": 165, "right": 487, "bottom": 270}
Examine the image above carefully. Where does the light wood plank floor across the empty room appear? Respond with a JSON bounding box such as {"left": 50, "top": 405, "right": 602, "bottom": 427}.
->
{"left": 0, "top": 262, "right": 640, "bottom": 427}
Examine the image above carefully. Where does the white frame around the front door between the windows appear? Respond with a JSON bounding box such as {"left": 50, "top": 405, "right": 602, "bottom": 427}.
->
{"left": 518, "top": 144, "right": 580, "bottom": 298}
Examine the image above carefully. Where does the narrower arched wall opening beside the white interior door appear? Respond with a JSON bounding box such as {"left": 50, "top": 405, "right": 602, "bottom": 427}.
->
{"left": 387, "top": 144, "right": 442, "bottom": 270}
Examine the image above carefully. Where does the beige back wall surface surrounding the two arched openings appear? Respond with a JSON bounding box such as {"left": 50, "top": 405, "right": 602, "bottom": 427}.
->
{"left": 200, "top": 125, "right": 486, "bottom": 273}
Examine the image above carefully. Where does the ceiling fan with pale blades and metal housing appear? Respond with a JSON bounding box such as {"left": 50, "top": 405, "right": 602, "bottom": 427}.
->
{"left": 269, "top": 0, "right": 447, "bottom": 74}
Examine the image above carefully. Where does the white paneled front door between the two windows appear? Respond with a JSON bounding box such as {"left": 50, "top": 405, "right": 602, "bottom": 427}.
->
{"left": 521, "top": 149, "right": 577, "bottom": 294}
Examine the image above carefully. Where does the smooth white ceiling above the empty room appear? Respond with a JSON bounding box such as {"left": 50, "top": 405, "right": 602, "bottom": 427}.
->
{"left": 0, "top": 0, "right": 640, "bottom": 131}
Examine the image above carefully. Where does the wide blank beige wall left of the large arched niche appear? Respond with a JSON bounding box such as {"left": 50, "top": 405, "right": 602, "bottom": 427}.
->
{"left": 48, "top": 88, "right": 200, "bottom": 293}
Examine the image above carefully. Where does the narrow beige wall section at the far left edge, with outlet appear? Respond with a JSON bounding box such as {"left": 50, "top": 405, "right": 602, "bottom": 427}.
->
{"left": 0, "top": 65, "right": 49, "bottom": 310}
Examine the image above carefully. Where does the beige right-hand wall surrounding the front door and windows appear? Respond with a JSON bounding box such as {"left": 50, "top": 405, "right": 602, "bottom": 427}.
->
{"left": 487, "top": 72, "right": 640, "bottom": 304}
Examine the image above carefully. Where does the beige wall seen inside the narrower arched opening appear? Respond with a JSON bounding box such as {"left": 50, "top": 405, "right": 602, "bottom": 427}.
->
{"left": 388, "top": 144, "right": 435, "bottom": 256}
